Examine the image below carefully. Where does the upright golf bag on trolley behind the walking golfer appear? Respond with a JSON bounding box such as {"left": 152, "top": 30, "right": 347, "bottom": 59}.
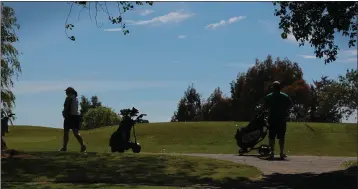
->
{"left": 109, "top": 107, "right": 146, "bottom": 153}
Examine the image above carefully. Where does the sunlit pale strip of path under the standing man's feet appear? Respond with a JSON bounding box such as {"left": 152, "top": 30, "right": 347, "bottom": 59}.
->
{"left": 183, "top": 154, "right": 357, "bottom": 175}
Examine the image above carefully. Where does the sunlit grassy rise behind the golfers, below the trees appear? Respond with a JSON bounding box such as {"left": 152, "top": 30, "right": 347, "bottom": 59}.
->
{"left": 5, "top": 122, "right": 357, "bottom": 156}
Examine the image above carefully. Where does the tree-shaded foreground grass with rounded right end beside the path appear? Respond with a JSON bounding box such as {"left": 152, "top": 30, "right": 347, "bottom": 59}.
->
{"left": 1, "top": 152, "right": 261, "bottom": 189}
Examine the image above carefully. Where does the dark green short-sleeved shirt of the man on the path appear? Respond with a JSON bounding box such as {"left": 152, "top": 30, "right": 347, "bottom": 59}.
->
{"left": 265, "top": 92, "right": 292, "bottom": 120}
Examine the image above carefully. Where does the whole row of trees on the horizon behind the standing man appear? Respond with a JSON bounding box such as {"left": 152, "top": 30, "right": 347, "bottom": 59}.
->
{"left": 171, "top": 55, "right": 358, "bottom": 123}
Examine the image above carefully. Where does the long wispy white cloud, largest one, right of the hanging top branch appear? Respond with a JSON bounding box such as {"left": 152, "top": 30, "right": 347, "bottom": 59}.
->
{"left": 125, "top": 10, "right": 194, "bottom": 25}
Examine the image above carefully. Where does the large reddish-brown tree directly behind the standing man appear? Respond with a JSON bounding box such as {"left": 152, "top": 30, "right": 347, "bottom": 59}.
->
{"left": 231, "top": 55, "right": 308, "bottom": 121}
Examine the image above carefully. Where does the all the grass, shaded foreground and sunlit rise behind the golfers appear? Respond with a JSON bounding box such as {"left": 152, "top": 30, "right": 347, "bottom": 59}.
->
{"left": 1, "top": 122, "right": 357, "bottom": 189}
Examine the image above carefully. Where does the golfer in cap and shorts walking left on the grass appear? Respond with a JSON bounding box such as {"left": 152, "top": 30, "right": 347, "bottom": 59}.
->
{"left": 60, "top": 87, "right": 86, "bottom": 152}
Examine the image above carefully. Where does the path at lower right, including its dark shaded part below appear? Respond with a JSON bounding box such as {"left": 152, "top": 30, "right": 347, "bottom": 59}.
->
{"left": 183, "top": 154, "right": 357, "bottom": 189}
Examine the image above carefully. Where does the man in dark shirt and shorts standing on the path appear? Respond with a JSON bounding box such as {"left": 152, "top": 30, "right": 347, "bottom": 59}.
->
{"left": 265, "top": 81, "right": 292, "bottom": 159}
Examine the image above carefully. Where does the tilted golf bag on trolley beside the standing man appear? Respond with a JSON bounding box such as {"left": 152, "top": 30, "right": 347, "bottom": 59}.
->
{"left": 235, "top": 112, "right": 270, "bottom": 156}
